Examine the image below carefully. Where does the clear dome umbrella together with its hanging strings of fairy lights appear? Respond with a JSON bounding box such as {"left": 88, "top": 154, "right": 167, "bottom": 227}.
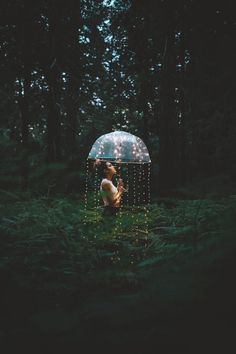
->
{"left": 85, "top": 131, "right": 151, "bottom": 239}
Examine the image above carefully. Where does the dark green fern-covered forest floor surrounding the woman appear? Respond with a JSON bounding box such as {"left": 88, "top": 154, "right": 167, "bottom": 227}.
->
{"left": 0, "top": 190, "right": 236, "bottom": 354}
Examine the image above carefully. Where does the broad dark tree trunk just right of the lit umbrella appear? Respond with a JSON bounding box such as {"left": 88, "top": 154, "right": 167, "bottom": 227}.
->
{"left": 159, "top": 1, "right": 177, "bottom": 192}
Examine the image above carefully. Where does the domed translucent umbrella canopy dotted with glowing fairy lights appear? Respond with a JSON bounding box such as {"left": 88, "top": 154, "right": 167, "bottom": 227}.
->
{"left": 88, "top": 131, "right": 151, "bottom": 164}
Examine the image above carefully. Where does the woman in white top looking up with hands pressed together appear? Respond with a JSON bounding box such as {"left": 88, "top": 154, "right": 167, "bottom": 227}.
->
{"left": 95, "top": 159, "right": 125, "bottom": 215}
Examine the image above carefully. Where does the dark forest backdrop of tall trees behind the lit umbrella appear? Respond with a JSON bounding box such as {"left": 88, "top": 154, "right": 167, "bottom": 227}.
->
{"left": 0, "top": 0, "right": 236, "bottom": 193}
